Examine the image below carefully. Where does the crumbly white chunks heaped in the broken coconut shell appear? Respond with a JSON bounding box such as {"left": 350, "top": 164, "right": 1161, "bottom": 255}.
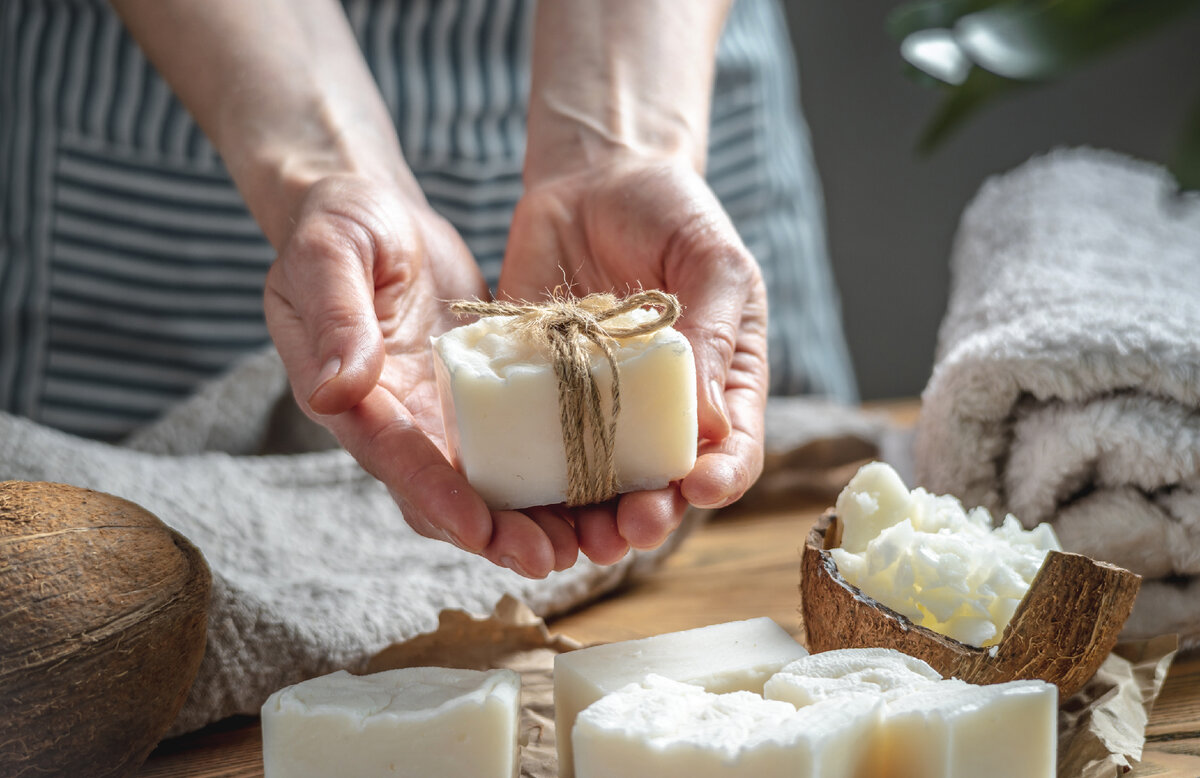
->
{"left": 829, "top": 462, "right": 1062, "bottom": 646}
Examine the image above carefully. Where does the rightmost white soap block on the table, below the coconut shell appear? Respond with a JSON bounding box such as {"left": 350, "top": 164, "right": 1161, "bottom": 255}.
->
{"left": 875, "top": 680, "right": 1058, "bottom": 778}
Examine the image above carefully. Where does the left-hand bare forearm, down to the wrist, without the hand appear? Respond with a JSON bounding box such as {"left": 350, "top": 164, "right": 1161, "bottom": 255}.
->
{"left": 112, "top": 0, "right": 422, "bottom": 249}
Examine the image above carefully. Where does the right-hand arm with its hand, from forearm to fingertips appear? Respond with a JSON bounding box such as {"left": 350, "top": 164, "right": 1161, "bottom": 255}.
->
{"left": 499, "top": 0, "right": 767, "bottom": 562}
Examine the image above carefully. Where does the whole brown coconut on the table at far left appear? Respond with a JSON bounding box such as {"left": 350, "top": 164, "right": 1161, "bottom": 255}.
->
{"left": 0, "top": 481, "right": 211, "bottom": 778}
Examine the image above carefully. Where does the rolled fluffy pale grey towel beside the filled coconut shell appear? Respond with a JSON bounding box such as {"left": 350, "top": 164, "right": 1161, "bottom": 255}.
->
{"left": 914, "top": 149, "right": 1200, "bottom": 644}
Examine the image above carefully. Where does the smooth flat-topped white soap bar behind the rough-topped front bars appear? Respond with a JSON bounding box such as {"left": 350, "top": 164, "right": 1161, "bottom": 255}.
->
{"left": 554, "top": 617, "right": 808, "bottom": 778}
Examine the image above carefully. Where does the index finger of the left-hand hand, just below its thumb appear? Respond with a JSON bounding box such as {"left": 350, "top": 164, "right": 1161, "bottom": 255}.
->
{"left": 326, "top": 387, "right": 493, "bottom": 553}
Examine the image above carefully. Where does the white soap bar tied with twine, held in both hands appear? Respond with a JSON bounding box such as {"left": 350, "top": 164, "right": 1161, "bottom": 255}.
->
{"left": 433, "top": 310, "right": 698, "bottom": 510}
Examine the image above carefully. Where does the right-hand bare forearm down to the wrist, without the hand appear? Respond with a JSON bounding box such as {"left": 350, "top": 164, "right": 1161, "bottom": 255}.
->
{"left": 526, "top": 0, "right": 728, "bottom": 186}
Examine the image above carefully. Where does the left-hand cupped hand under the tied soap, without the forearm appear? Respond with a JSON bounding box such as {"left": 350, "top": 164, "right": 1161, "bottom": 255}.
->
{"left": 264, "top": 175, "right": 578, "bottom": 577}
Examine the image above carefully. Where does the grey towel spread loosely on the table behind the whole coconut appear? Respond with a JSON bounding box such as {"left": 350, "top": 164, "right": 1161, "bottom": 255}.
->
{"left": 0, "top": 343, "right": 897, "bottom": 734}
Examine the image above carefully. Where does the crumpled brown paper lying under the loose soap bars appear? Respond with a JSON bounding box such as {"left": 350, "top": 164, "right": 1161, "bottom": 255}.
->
{"left": 367, "top": 597, "right": 1178, "bottom": 778}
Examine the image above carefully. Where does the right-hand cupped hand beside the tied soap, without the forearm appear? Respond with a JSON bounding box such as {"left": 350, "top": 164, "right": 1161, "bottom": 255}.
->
{"left": 498, "top": 155, "right": 768, "bottom": 564}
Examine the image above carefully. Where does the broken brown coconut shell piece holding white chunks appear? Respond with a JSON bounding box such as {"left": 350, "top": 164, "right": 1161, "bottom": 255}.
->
{"left": 800, "top": 511, "right": 1141, "bottom": 700}
